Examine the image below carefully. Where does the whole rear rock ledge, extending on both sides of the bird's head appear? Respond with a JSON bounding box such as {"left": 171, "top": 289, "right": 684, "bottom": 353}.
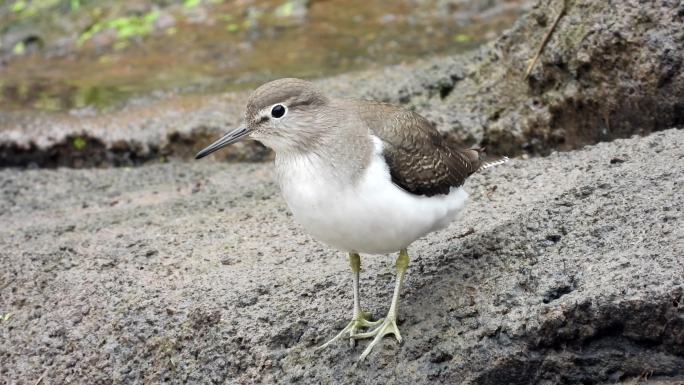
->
{"left": 0, "top": 0, "right": 684, "bottom": 167}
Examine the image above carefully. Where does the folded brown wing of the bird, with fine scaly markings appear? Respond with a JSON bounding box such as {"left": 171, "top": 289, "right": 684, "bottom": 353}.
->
{"left": 359, "top": 102, "right": 482, "bottom": 196}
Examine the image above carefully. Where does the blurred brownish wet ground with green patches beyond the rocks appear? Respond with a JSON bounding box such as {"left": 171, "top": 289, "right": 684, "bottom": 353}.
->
{"left": 0, "top": 0, "right": 525, "bottom": 114}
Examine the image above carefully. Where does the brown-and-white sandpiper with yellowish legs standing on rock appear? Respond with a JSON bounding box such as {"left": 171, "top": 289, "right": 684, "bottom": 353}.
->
{"left": 196, "top": 78, "right": 508, "bottom": 361}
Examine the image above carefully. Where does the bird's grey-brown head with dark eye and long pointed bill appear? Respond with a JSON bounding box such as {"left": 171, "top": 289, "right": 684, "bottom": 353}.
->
{"left": 195, "top": 78, "right": 329, "bottom": 159}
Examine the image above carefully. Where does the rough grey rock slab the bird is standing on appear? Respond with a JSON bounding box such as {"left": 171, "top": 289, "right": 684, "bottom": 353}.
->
{"left": 0, "top": 129, "right": 684, "bottom": 385}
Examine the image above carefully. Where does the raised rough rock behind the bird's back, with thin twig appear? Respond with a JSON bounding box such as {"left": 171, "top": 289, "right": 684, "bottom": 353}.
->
{"left": 326, "top": 0, "right": 684, "bottom": 154}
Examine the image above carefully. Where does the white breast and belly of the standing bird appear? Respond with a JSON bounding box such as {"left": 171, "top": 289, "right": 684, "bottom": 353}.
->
{"left": 279, "top": 138, "right": 468, "bottom": 254}
